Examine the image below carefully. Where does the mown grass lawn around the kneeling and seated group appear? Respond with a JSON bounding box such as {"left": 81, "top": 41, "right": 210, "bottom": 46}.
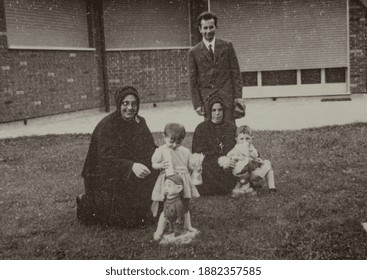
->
{"left": 0, "top": 123, "right": 367, "bottom": 260}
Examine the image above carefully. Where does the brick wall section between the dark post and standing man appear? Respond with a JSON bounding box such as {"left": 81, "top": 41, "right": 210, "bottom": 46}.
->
{"left": 107, "top": 49, "right": 190, "bottom": 103}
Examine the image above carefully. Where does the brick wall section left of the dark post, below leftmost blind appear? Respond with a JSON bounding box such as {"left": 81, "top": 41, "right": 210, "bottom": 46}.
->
{"left": 0, "top": 50, "right": 102, "bottom": 122}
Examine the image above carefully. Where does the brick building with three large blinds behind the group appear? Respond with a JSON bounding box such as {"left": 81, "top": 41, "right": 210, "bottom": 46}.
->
{"left": 0, "top": 0, "right": 367, "bottom": 122}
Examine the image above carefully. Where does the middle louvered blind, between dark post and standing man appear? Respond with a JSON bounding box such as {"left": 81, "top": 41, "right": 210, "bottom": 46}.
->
{"left": 104, "top": 0, "right": 190, "bottom": 49}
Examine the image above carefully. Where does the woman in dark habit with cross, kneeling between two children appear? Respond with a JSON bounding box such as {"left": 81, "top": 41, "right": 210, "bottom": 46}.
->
{"left": 192, "top": 97, "right": 236, "bottom": 195}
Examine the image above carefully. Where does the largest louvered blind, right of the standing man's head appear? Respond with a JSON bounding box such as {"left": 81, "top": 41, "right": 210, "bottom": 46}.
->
{"left": 210, "top": 0, "right": 348, "bottom": 71}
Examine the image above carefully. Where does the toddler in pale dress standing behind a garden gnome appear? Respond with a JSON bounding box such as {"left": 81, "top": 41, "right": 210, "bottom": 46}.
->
{"left": 152, "top": 123, "right": 200, "bottom": 240}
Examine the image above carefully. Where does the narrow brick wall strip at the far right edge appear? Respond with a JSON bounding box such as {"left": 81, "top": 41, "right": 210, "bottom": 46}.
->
{"left": 349, "top": 0, "right": 367, "bottom": 93}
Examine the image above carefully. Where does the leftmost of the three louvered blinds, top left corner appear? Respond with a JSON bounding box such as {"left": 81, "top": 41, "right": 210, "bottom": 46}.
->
{"left": 5, "top": 0, "right": 88, "bottom": 48}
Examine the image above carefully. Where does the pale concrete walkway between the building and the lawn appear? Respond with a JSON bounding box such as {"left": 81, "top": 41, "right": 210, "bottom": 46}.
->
{"left": 0, "top": 95, "right": 367, "bottom": 138}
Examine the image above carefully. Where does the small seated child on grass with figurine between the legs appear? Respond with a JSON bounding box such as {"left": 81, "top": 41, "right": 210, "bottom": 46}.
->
{"left": 227, "top": 125, "right": 276, "bottom": 196}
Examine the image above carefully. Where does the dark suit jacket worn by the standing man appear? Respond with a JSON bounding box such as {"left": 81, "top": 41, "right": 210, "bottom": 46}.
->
{"left": 188, "top": 38, "right": 242, "bottom": 118}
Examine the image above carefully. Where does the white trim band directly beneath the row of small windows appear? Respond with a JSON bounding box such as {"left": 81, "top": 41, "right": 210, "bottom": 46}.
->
{"left": 242, "top": 83, "right": 350, "bottom": 98}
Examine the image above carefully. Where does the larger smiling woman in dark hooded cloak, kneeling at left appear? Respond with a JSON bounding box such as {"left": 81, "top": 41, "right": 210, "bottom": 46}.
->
{"left": 77, "top": 87, "right": 158, "bottom": 227}
